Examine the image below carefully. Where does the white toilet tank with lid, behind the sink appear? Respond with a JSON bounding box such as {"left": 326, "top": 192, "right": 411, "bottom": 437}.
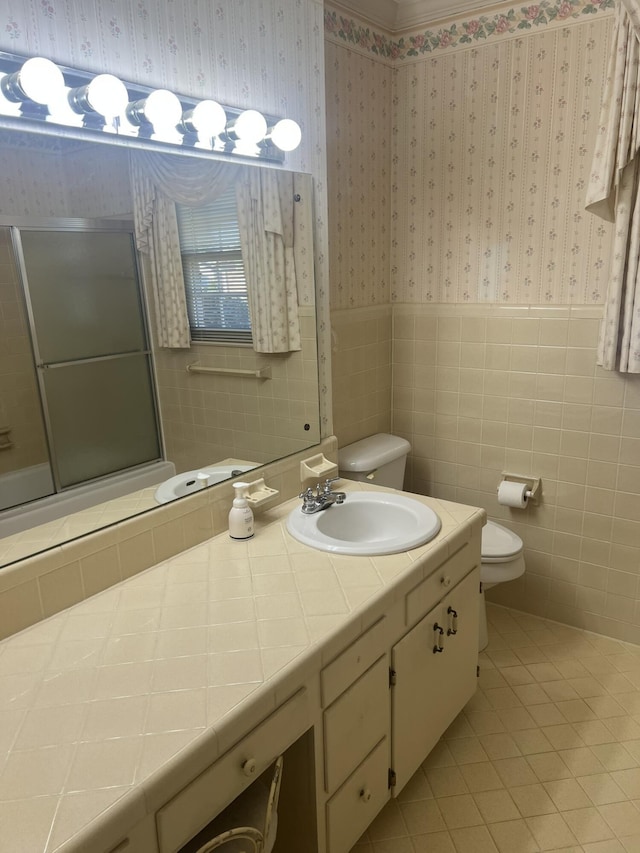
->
{"left": 338, "top": 432, "right": 411, "bottom": 489}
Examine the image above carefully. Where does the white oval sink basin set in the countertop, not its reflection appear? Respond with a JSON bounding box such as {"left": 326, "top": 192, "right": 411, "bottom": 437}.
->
{"left": 287, "top": 492, "right": 440, "bottom": 556}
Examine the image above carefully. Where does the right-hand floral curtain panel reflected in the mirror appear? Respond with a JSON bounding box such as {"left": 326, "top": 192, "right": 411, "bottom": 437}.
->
{"left": 236, "top": 169, "right": 301, "bottom": 353}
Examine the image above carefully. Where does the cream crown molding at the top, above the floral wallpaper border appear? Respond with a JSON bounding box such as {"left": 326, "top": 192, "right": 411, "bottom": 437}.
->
{"left": 338, "top": 0, "right": 502, "bottom": 32}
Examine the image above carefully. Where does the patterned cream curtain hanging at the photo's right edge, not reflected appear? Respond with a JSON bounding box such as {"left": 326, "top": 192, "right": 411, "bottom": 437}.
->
{"left": 587, "top": 0, "right": 640, "bottom": 373}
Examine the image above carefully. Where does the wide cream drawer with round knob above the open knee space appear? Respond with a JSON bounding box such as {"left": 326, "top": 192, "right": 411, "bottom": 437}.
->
{"left": 156, "top": 688, "right": 310, "bottom": 853}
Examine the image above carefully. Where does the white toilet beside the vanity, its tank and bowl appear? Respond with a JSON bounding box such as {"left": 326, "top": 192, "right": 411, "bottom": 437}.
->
{"left": 338, "top": 433, "right": 525, "bottom": 649}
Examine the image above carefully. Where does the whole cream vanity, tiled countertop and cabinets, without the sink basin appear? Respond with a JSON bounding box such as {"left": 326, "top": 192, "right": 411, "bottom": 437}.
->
{"left": 0, "top": 483, "right": 484, "bottom": 853}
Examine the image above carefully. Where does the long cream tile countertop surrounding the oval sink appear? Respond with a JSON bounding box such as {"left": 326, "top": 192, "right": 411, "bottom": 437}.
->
{"left": 0, "top": 482, "right": 484, "bottom": 853}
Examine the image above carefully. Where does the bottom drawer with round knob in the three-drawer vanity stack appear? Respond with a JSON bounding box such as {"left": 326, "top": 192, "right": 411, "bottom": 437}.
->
{"left": 327, "top": 738, "right": 390, "bottom": 853}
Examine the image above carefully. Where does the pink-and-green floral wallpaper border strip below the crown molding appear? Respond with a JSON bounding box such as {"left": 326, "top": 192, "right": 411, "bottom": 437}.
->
{"left": 324, "top": 0, "right": 615, "bottom": 62}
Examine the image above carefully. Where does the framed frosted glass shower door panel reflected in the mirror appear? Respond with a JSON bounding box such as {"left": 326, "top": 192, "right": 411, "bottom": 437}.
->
{"left": 14, "top": 228, "right": 161, "bottom": 490}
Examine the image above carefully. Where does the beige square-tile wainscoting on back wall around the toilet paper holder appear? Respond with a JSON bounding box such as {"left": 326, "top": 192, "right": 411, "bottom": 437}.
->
{"left": 392, "top": 304, "right": 640, "bottom": 642}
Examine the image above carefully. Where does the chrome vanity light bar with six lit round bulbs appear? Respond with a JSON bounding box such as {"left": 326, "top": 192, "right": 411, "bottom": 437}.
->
{"left": 0, "top": 52, "right": 302, "bottom": 163}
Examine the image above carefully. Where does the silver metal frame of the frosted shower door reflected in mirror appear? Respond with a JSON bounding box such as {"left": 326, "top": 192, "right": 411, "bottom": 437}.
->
{"left": 6, "top": 216, "right": 166, "bottom": 494}
